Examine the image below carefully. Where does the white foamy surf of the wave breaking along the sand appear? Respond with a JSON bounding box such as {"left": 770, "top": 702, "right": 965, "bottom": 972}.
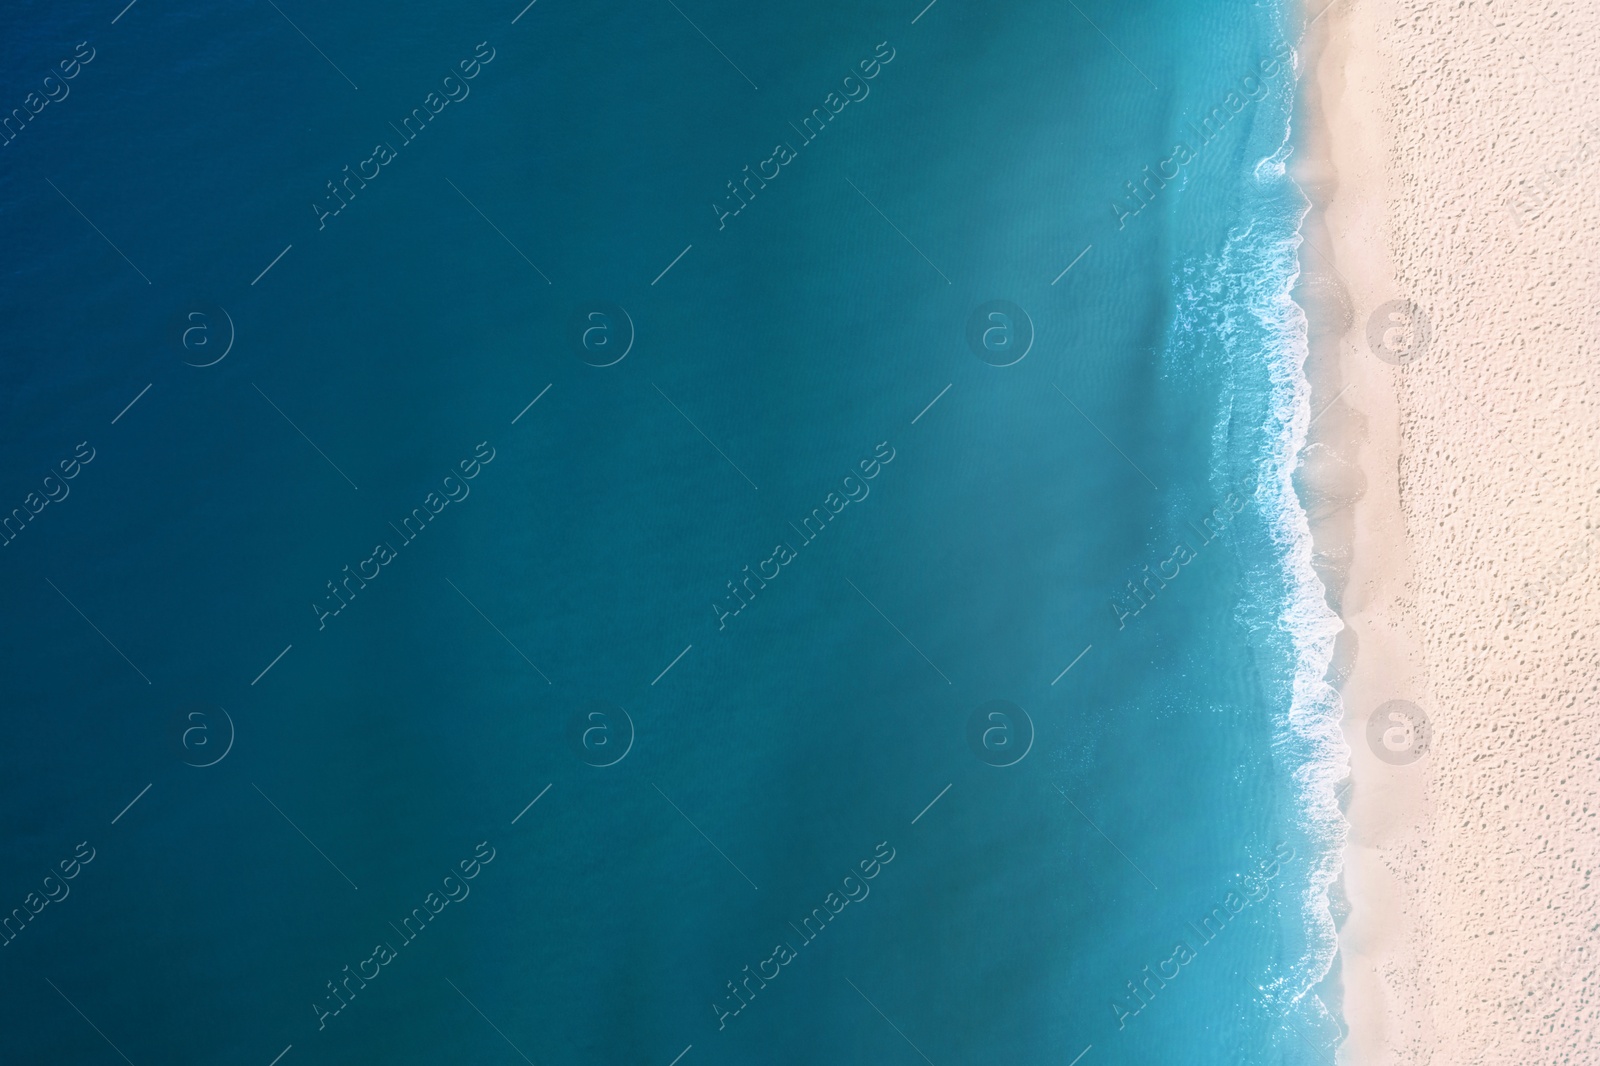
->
{"left": 1163, "top": 49, "right": 1350, "bottom": 1021}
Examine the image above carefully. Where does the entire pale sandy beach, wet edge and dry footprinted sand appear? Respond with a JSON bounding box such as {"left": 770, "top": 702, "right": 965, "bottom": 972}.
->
{"left": 1296, "top": 0, "right": 1600, "bottom": 1066}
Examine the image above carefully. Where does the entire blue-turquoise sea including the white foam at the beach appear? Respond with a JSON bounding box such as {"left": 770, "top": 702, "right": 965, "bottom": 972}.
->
{"left": 0, "top": 0, "right": 1339, "bottom": 1066}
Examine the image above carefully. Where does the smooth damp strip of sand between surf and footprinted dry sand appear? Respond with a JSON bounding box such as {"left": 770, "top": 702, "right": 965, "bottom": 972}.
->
{"left": 1291, "top": 2, "right": 1432, "bottom": 1063}
